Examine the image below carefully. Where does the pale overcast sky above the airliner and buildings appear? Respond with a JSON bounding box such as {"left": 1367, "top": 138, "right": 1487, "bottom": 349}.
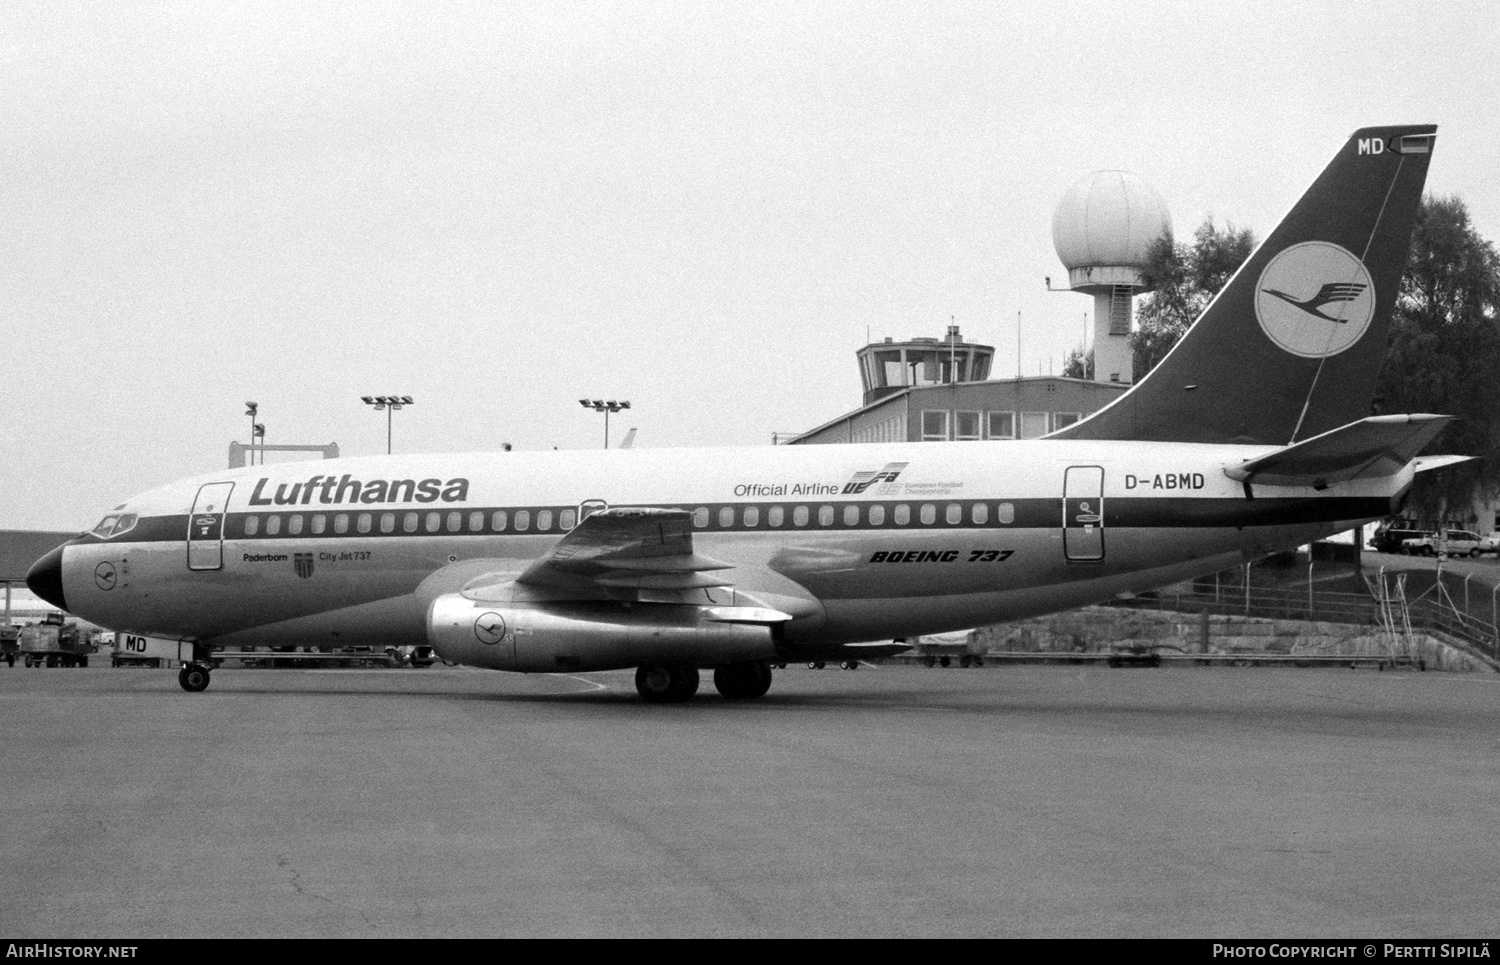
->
{"left": 0, "top": 0, "right": 1500, "bottom": 530}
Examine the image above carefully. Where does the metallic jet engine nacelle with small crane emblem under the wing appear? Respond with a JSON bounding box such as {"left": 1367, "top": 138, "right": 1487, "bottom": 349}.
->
{"left": 428, "top": 593, "right": 776, "bottom": 672}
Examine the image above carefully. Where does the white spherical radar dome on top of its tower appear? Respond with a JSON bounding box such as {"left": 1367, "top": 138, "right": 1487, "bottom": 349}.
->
{"left": 1052, "top": 171, "right": 1172, "bottom": 288}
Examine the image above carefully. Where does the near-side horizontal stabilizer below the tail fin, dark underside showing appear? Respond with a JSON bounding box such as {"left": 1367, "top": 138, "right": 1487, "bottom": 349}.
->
{"left": 1224, "top": 414, "right": 1454, "bottom": 489}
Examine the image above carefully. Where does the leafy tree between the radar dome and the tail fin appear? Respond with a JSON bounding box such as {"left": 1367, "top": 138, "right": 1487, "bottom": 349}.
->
{"left": 1131, "top": 215, "right": 1256, "bottom": 381}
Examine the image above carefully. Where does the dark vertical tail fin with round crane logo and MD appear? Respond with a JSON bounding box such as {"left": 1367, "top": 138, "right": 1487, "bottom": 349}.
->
{"left": 1053, "top": 125, "right": 1437, "bottom": 446}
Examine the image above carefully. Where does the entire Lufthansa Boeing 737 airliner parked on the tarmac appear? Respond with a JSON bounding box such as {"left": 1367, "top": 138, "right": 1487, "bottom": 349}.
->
{"left": 27, "top": 126, "right": 1452, "bottom": 702}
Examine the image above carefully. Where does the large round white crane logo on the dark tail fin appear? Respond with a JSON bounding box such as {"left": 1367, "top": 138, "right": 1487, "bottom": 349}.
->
{"left": 1256, "top": 242, "right": 1376, "bottom": 359}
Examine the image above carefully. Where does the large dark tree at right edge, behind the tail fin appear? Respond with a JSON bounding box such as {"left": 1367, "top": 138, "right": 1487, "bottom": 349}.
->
{"left": 1374, "top": 195, "right": 1500, "bottom": 521}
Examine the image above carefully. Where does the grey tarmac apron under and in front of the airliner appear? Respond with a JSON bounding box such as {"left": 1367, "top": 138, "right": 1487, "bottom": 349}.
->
{"left": 0, "top": 665, "right": 1500, "bottom": 939}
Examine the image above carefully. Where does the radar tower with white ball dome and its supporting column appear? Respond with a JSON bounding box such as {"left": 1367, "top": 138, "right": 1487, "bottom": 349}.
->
{"left": 1052, "top": 171, "right": 1172, "bottom": 383}
